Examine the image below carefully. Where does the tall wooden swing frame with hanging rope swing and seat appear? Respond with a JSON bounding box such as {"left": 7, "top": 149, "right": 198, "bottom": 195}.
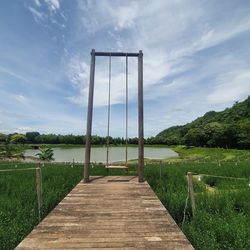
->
{"left": 83, "top": 49, "right": 144, "bottom": 183}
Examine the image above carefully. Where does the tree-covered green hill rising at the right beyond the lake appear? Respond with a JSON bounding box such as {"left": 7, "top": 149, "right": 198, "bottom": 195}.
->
{"left": 155, "top": 96, "right": 250, "bottom": 149}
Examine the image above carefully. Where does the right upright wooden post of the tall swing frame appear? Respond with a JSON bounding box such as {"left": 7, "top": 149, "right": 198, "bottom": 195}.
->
{"left": 138, "top": 50, "right": 144, "bottom": 182}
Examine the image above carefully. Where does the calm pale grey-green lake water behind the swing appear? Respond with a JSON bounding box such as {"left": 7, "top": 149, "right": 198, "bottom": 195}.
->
{"left": 24, "top": 147, "right": 178, "bottom": 162}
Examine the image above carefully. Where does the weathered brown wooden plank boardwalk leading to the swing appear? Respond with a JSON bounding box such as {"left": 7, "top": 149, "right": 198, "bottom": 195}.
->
{"left": 16, "top": 176, "right": 193, "bottom": 250}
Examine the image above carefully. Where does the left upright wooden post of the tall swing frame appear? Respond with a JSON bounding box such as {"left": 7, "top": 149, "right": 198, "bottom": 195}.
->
{"left": 83, "top": 49, "right": 95, "bottom": 183}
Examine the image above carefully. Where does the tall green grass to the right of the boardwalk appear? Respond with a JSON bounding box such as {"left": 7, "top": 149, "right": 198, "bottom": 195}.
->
{"left": 146, "top": 161, "right": 250, "bottom": 249}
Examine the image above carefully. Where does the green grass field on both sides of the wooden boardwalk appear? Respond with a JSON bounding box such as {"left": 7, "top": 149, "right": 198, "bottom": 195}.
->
{"left": 0, "top": 147, "right": 250, "bottom": 249}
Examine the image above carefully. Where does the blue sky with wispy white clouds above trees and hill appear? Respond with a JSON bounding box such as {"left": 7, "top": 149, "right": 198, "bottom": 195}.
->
{"left": 0, "top": 0, "right": 250, "bottom": 137}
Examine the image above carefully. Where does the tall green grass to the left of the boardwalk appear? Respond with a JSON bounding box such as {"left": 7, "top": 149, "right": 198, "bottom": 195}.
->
{"left": 0, "top": 163, "right": 82, "bottom": 250}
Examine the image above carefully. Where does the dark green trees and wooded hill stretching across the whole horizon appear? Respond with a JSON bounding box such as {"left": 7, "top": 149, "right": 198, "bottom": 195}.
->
{"left": 0, "top": 97, "right": 250, "bottom": 149}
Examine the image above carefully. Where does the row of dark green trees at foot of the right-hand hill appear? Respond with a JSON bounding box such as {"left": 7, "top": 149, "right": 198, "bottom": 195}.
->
{"left": 150, "top": 122, "right": 250, "bottom": 149}
